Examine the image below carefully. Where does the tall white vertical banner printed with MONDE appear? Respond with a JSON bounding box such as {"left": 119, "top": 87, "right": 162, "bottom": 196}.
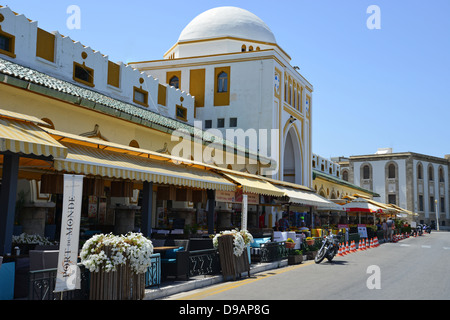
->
{"left": 55, "top": 174, "right": 83, "bottom": 292}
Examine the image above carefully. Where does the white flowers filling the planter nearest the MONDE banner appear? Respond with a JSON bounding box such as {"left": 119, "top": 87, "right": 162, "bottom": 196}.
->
{"left": 80, "top": 233, "right": 153, "bottom": 274}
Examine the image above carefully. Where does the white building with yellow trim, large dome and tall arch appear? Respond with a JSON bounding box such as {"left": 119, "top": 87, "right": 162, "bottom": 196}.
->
{"left": 130, "top": 7, "right": 313, "bottom": 187}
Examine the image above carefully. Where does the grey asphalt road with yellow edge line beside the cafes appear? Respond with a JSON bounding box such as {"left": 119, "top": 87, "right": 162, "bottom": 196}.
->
{"left": 167, "top": 231, "right": 450, "bottom": 301}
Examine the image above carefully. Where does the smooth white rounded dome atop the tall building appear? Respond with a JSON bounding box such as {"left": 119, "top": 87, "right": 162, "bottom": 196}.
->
{"left": 178, "top": 7, "right": 276, "bottom": 44}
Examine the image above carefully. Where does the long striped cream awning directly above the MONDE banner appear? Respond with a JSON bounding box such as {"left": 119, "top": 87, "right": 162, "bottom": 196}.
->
{"left": 54, "top": 142, "right": 236, "bottom": 191}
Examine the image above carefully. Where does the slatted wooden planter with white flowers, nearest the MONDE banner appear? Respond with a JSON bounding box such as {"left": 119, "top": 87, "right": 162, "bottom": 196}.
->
{"left": 81, "top": 233, "right": 153, "bottom": 300}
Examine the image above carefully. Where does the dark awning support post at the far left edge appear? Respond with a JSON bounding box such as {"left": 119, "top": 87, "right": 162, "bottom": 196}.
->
{"left": 0, "top": 154, "right": 19, "bottom": 256}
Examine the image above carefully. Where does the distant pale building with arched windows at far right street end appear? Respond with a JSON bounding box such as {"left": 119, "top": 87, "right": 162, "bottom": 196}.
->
{"left": 336, "top": 149, "right": 450, "bottom": 229}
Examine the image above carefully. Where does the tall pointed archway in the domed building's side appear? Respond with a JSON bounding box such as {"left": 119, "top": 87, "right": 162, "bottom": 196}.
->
{"left": 283, "top": 126, "right": 303, "bottom": 185}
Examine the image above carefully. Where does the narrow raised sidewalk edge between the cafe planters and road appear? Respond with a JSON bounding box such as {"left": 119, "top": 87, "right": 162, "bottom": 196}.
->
{"left": 144, "top": 259, "right": 288, "bottom": 300}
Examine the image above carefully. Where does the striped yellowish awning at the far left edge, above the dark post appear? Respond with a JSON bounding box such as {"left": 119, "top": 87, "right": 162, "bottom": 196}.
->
{"left": 0, "top": 116, "right": 67, "bottom": 158}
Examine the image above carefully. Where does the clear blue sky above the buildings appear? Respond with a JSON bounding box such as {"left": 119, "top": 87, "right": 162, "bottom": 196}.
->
{"left": 0, "top": 0, "right": 450, "bottom": 158}
